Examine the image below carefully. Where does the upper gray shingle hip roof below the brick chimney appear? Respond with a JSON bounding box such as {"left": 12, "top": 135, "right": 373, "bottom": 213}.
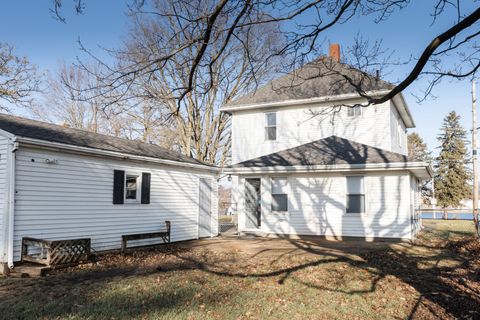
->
{"left": 226, "top": 57, "right": 393, "bottom": 108}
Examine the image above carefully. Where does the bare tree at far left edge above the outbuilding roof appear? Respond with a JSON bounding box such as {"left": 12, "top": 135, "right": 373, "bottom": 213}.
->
{"left": 0, "top": 42, "right": 40, "bottom": 110}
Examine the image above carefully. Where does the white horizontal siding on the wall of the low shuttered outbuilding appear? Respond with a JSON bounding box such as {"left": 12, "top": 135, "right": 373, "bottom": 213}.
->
{"left": 14, "top": 148, "right": 217, "bottom": 260}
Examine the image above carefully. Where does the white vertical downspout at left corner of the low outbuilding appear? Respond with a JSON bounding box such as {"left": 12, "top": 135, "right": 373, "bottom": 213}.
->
{"left": 6, "top": 137, "right": 18, "bottom": 269}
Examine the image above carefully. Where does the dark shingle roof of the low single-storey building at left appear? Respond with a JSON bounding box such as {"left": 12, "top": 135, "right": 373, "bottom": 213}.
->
{"left": 0, "top": 114, "right": 210, "bottom": 165}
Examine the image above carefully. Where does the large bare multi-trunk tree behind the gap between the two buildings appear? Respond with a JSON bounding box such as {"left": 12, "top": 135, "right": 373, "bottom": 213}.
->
{"left": 73, "top": 0, "right": 279, "bottom": 165}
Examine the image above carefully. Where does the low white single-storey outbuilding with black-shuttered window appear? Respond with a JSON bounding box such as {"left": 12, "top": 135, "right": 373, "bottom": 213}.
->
{"left": 0, "top": 114, "right": 218, "bottom": 267}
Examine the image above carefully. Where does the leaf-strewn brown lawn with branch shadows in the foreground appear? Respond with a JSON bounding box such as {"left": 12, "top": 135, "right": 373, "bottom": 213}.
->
{"left": 0, "top": 221, "right": 480, "bottom": 320}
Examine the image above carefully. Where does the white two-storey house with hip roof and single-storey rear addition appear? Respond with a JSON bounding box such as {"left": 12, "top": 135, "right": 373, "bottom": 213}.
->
{"left": 221, "top": 44, "right": 432, "bottom": 239}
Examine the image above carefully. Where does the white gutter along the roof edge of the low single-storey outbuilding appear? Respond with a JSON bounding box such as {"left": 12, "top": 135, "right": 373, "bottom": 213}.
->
{"left": 17, "top": 137, "right": 220, "bottom": 173}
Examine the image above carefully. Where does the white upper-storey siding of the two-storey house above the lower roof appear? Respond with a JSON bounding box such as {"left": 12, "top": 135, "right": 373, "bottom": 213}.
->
{"left": 232, "top": 101, "right": 406, "bottom": 163}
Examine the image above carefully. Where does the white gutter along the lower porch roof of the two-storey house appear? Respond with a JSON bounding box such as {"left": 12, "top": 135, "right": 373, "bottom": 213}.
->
{"left": 224, "top": 162, "right": 432, "bottom": 176}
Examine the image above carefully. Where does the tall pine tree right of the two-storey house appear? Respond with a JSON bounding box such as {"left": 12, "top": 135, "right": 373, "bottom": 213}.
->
{"left": 434, "top": 111, "right": 471, "bottom": 219}
